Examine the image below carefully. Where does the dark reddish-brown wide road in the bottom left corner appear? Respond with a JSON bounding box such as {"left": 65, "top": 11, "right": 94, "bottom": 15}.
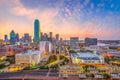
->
{"left": 0, "top": 70, "right": 59, "bottom": 80}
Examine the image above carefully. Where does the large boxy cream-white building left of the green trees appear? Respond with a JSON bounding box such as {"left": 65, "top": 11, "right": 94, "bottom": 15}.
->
{"left": 15, "top": 50, "right": 44, "bottom": 65}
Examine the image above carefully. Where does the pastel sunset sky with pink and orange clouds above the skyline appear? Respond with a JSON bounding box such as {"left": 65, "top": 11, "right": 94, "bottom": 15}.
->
{"left": 0, "top": 0, "right": 120, "bottom": 39}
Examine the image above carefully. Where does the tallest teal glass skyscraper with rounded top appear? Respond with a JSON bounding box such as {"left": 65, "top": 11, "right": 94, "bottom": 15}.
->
{"left": 34, "top": 19, "right": 40, "bottom": 42}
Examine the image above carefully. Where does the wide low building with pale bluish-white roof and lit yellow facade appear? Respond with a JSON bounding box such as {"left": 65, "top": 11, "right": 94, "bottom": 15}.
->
{"left": 71, "top": 52, "right": 104, "bottom": 64}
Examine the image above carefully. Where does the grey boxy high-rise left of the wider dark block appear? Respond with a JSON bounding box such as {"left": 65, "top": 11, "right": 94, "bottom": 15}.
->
{"left": 70, "top": 37, "right": 79, "bottom": 49}
